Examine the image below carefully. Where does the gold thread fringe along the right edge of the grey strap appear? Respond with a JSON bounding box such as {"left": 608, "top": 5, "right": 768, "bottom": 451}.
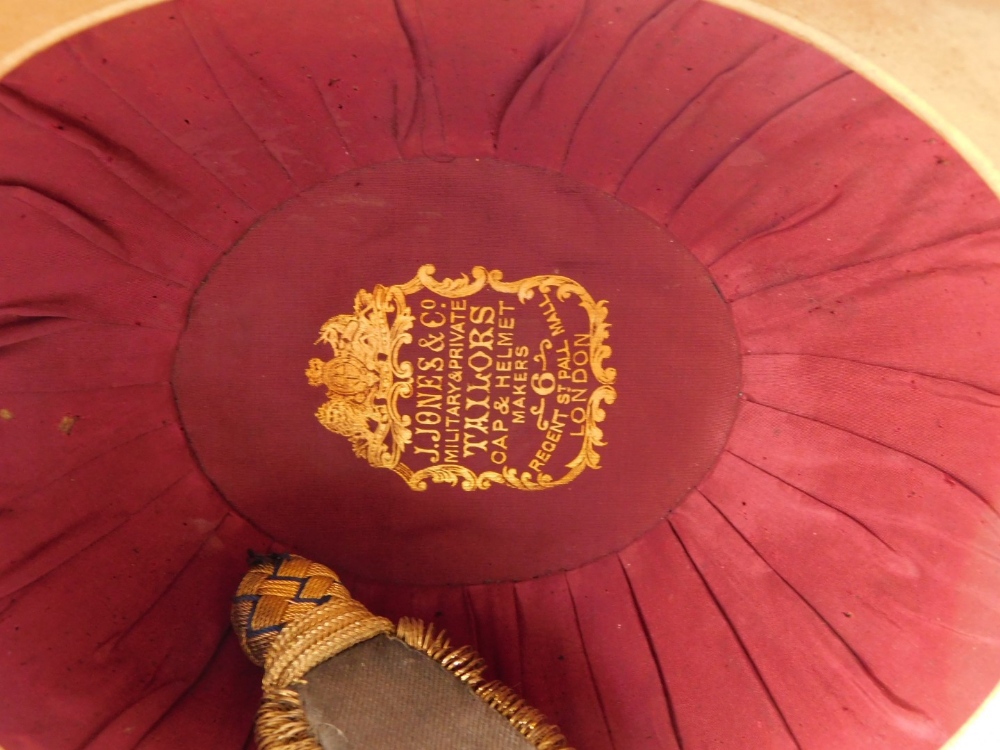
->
{"left": 394, "top": 617, "right": 573, "bottom": 750}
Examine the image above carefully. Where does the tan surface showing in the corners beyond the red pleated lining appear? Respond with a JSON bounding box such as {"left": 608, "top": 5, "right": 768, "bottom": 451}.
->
{"left": 0, "top": 0, "right": 1000, "bottom": 750}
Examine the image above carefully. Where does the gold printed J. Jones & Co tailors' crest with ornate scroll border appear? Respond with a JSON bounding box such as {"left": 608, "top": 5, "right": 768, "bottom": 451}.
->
{"left": 306, "top": 265, "right": 617, "bottom": 490}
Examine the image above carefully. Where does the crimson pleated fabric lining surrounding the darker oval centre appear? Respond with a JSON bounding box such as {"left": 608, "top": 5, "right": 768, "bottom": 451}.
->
{"left": 0, "top": 0, "right": 1000, "bottom": 750}
